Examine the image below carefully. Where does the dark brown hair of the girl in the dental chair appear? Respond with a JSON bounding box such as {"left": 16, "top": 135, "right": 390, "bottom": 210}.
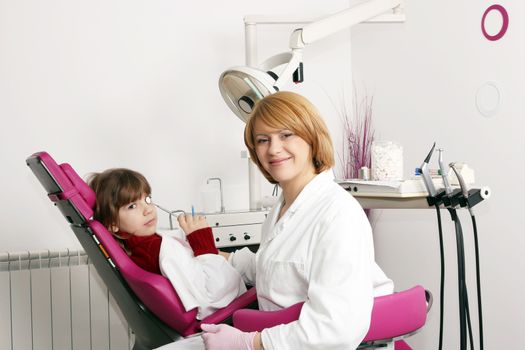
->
{"left": 88, "top": 168, "right": 151, "bottom": 239}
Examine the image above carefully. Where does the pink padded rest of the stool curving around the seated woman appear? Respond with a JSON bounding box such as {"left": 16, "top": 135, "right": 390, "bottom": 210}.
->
{"left": 233, "top": 286, "right": 427, "bottom": 341}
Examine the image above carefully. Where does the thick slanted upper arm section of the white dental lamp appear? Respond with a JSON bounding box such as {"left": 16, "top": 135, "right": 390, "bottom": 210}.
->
{"left": 290, "top": 0, "right": 401, "bottom": 49}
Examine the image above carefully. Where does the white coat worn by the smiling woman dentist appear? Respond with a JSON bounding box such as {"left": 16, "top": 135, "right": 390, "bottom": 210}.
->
{"left": 229, "top": 171, "right": 393, "bottom": 350}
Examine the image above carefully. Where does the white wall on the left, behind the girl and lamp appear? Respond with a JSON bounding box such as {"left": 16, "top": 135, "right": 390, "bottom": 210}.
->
{"left": 0, "top": 0, "right": 351, "bottom": 251}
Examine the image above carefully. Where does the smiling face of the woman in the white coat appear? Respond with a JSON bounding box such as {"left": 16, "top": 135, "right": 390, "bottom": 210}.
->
{"left": 253, "top": 120, "right": 315, "bottom": 187}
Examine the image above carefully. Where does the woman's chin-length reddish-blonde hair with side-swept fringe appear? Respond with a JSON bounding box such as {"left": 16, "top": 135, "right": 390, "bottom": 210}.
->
{"left": 244, "top": 91, "right": 335, "bottom": 184}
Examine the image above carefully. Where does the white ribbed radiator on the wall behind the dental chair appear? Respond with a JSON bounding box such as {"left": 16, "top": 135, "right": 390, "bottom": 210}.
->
{"left": 0, "top": 250, "right": 133, "bottom": 350}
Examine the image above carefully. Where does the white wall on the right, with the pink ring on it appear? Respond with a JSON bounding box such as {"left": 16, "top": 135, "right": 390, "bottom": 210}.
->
{"left": 352, "top": 0, "right": 525, "bottom": 349}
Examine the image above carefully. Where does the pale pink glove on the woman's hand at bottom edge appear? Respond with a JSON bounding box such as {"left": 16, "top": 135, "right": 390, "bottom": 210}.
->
{"left": 201, "top": 324, "right": 257, "bottom": 350}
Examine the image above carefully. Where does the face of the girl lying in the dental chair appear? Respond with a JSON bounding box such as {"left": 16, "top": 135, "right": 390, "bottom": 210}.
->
{"left": 114, "top": 194, "right": 157, "bottom": 236}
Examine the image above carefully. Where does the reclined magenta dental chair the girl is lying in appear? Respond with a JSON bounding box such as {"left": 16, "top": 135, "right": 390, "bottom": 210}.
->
{"left": 26, "top": 152, "right": 256, "bottom": 349}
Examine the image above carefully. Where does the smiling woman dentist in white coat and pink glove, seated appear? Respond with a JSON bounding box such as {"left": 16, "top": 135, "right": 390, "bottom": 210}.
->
{"left": 202, "top": 92, "right": 393, "bottom": 350}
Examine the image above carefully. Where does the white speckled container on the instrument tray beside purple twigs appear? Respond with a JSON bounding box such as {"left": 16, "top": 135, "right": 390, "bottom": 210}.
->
{"left": 371, "top": 141, "right": 403, "bottom": 181}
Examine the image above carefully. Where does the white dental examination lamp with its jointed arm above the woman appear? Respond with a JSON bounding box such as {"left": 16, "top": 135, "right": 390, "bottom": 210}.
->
{"left": 219, "top": 0, "right": 401, "bottom": 122}
